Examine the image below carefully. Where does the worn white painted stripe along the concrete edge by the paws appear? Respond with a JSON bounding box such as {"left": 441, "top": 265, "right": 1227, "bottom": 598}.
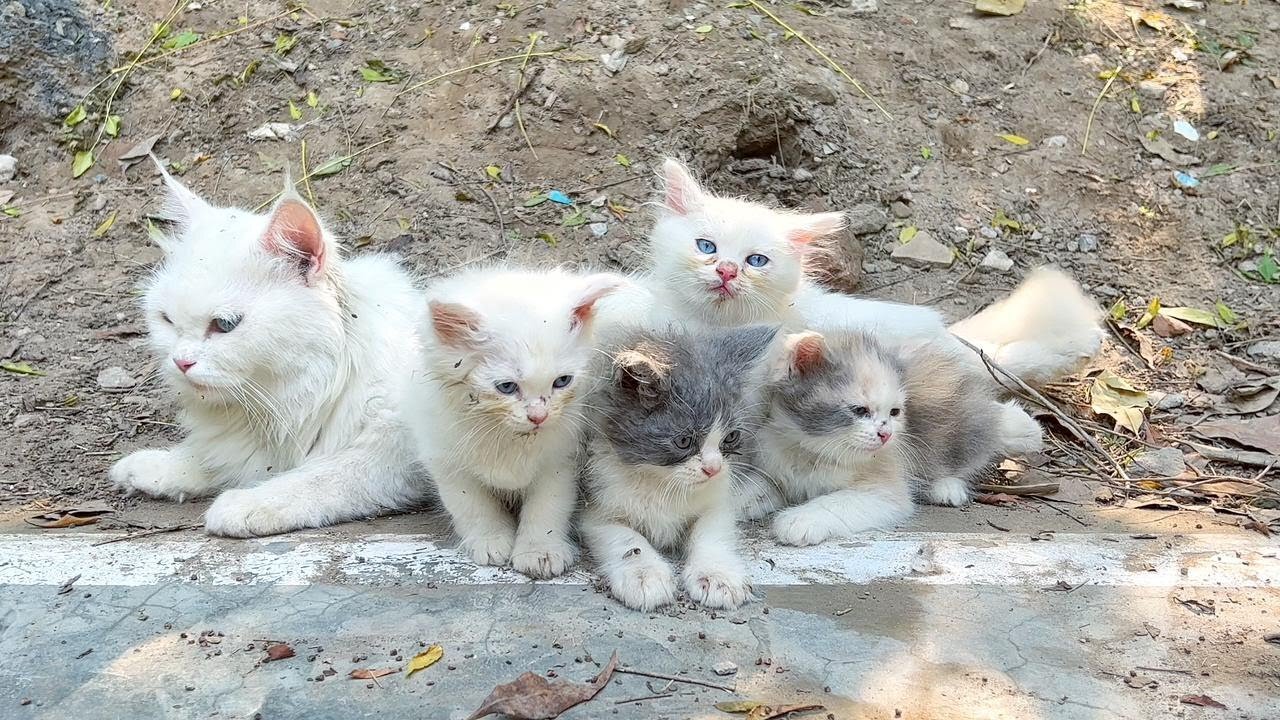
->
{"left": 0, "top": 533, "right": 1280, "bottom": 588}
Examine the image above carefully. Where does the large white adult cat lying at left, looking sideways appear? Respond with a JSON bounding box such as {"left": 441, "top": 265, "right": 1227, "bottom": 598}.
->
{"left": 110, "top": 168, "right": 425, "bottom": 537}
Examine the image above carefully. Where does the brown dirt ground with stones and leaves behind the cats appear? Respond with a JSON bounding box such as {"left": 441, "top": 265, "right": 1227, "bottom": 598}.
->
{"left": 0, "top": 0, "right": 1280, "bottom": 510}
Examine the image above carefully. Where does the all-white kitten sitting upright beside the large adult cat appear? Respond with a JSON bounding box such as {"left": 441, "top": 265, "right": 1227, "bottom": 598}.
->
{"left": 407, "top": 268, "right": 626, "bottom": 578}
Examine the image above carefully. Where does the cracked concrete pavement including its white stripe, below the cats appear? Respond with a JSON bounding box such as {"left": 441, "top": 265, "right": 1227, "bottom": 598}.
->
{"left": 0, "top": 509, "right": 1280, "bottom": 720}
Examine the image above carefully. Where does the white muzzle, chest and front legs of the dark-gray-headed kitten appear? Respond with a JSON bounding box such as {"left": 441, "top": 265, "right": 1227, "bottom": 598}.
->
{"left": 582, "top": 429, "right": 751, "bottom": 611}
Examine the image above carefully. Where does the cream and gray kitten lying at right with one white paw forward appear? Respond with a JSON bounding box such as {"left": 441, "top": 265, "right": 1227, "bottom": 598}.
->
{"left": 748, "top": 332, "right": 1041, "bottom": 544}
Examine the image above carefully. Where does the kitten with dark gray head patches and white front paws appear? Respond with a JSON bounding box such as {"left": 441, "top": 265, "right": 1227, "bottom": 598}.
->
{"left": 582, "top": 327, "right": 776, "bottom": 610}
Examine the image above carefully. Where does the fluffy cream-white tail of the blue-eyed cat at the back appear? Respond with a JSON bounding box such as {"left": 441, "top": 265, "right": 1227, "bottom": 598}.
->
{"left": 950, "top": 268, "right": 1103, "bottom": 386}
